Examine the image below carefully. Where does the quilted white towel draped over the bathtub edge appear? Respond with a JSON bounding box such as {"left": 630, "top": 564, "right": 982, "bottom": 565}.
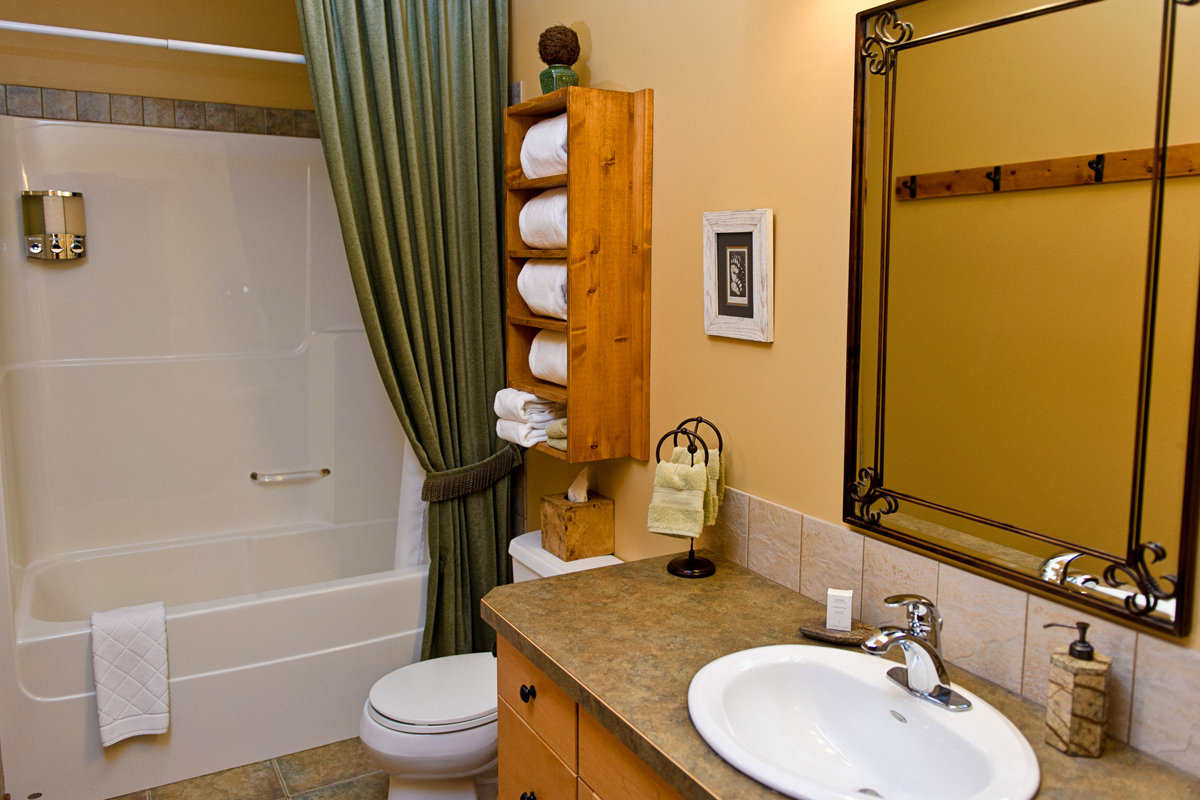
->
{"left": 91, "top": 603, "right": 170, "bottom": 747}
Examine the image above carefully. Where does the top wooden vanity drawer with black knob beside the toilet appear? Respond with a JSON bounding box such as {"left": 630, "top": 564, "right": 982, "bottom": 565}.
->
{"left": 496, "top": 638, "right": 576, "bottom": 767}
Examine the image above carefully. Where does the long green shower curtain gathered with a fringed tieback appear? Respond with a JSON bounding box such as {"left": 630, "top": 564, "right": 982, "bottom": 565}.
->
{"left": 296, "top": 0, "right": 520, "bottom": 658}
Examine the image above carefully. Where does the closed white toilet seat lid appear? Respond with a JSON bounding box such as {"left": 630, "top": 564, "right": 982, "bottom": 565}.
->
{"left": 370, "top": 652, "right": 496, "bottom": 726}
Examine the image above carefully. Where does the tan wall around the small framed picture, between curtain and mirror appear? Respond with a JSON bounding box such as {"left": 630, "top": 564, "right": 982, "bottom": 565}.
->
{"left": 510, "top": 0, "right": 1200, "bottom": 649}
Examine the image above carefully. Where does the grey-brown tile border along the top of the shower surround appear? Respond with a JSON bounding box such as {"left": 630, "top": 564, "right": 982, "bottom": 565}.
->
{"left": 0, "top": 84, "right": 320, "bottom": 139}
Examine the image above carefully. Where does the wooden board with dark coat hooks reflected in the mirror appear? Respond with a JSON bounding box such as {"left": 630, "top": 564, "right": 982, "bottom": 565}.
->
{"left": 893, "top": 143, "right": 1200, "bottom": 201}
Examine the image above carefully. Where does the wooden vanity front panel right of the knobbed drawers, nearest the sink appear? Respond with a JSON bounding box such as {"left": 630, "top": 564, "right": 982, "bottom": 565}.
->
{"left": 578, "top": 709, "right": 683, "bottom": 800}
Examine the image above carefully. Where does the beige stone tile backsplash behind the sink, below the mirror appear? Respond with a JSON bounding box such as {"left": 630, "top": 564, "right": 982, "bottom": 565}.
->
{"left": 697, "top": 488, "right": 1200, "bottom": 777}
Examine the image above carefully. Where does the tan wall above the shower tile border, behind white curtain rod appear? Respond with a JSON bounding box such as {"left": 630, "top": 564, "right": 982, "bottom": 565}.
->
{"left": 0, "top": 0, "right": 312, "bottom": 108}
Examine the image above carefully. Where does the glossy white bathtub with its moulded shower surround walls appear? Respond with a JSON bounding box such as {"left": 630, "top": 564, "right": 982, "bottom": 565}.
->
{"left": 0, "top": 116, "right": 417, "bottom": 800}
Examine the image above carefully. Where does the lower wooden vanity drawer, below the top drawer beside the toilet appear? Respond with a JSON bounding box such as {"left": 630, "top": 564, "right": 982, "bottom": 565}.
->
{"left": 497, "top": 699, "right": 578, "bottom": 800}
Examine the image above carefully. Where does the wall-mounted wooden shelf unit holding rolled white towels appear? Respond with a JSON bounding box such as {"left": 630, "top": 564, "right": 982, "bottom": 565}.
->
{"left": 504, "top": 86, "right": 654, "bottom": 463}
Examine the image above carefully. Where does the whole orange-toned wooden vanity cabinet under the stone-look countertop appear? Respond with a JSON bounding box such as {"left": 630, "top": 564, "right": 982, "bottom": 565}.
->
{"left": 497, "top": 638, "right": 683, "bottom": 800}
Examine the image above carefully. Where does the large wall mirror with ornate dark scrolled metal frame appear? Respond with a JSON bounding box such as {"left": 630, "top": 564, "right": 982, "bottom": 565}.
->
{"left": 844, "top": 0, "right": 1200, "bottom": 636}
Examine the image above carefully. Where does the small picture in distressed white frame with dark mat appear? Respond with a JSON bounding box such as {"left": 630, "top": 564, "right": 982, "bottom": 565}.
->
{"left": 704, "top": 209, "right": 775, "bottom": 342}
